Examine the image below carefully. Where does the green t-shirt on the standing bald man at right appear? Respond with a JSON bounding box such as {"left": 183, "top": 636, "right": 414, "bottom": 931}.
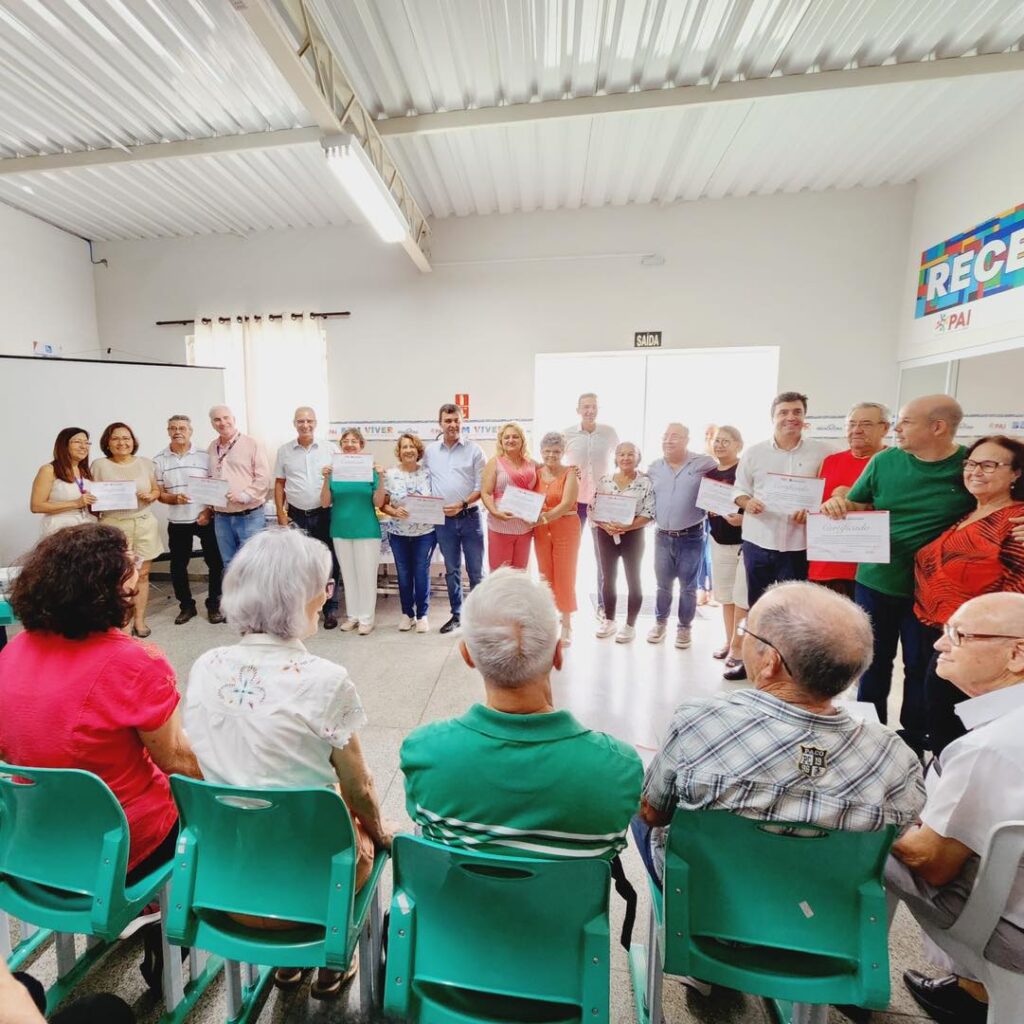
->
{"left": 847, "top": 444, "right": 975, "bottom": 597}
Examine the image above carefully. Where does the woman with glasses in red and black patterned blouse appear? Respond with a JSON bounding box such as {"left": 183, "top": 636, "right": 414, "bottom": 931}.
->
{"left": 913, "top": 434, "right": 1024, "bottom": 755}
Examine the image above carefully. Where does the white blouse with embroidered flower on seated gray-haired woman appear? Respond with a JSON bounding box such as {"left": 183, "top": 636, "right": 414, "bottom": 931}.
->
{"left": 184, "top": 633, "right": 367, "bottom": 787}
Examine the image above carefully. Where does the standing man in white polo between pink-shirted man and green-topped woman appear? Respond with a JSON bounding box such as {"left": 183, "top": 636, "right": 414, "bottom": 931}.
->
{"left": 273, "top": 406, "right": 341, "bottom": 630}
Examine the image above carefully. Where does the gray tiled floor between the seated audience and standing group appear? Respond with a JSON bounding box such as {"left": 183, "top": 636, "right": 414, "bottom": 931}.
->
{"left": 8, "top": 569, "right": 928, "bottom": 1024}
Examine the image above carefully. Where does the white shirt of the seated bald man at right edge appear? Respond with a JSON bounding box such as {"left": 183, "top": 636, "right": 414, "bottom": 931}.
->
{"left": 921, "top": 682, "right": 1024, "bottom": 928}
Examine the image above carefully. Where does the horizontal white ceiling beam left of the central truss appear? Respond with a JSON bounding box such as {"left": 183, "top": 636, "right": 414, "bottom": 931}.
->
{"left": 0, "top": 126, "right": 322, "bottom": 175}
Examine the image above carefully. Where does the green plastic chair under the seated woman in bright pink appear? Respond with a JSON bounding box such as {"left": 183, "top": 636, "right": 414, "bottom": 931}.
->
{"left": 0, "top": 763, "right": 218, "bottom": 1021}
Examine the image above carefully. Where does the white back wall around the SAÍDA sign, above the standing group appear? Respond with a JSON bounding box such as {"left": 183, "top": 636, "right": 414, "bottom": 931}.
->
{"left": 96, "top": 186, "right": 912, "bottom": 419}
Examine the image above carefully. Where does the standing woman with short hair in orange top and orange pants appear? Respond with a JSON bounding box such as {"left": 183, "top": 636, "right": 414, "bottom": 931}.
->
{"left": 534, "top": 432, "right": 581, "bottom": 646}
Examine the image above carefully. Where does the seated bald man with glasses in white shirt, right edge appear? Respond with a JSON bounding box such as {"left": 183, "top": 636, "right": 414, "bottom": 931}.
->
{"left": 886, "top": 593, "right": 1024, "bottom": 1024}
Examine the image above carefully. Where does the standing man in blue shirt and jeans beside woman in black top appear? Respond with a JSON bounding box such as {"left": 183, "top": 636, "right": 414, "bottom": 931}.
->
{"left": 647, "top": 423, "right": 718, "bottom": 647}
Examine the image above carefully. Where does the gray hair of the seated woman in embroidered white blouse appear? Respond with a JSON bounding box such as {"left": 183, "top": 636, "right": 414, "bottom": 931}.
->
{"left": 220, "top": 526, "right": 331, "bottom": 640}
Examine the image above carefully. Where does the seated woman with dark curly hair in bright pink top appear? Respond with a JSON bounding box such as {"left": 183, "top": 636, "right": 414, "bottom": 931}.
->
{"left": 0, "top": 523, "right": 203, "bottom": 885}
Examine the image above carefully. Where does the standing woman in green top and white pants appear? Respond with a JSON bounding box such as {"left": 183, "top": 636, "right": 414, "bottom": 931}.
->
{"left": 321, "top": 427, "right": 385, "bottom": 637}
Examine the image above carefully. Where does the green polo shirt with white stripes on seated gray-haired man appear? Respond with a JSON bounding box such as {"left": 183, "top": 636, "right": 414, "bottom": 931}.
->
{"left": 401, "top": 705, "right": 643, "bottom": 859}
